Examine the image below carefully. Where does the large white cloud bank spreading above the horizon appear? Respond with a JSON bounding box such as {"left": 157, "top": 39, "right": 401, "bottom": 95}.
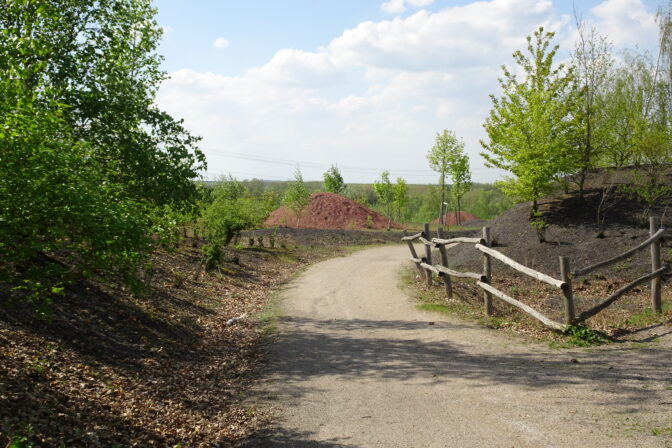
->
{"left": 158, "top": 0, "right": 655, "bottom": 182}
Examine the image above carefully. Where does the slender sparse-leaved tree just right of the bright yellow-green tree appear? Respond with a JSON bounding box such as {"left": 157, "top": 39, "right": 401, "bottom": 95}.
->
{"left": 572, "top": 12, "right": 613, "bottom": 199}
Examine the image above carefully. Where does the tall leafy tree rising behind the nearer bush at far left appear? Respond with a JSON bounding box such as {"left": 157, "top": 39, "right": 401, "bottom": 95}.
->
{"left": 0, "top": 0, "right": 205, "bottom": 206}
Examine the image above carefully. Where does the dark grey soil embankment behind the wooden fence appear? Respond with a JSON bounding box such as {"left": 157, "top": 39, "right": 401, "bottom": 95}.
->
{"left": 448, "top": 187, "right": 672, "bottom": 278}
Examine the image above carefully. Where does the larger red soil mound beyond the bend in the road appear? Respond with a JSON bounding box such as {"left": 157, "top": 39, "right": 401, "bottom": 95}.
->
{"left": 265, "top": 193, "right": 401, "bottom": 229}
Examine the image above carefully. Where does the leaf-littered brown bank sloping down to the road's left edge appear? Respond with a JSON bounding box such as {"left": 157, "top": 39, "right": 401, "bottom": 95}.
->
{"left": 0, "top": 233, "right": 396, "bottom": 447}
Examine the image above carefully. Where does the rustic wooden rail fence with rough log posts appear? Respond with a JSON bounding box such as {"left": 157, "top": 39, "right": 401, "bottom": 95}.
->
{"left": 402, "top": 217, "right": 670, "bottom": 330}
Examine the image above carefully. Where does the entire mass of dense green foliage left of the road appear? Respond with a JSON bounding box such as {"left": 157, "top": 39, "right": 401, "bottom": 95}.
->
{"left": 0, "top": 0, "right": 205, "bottom": 308}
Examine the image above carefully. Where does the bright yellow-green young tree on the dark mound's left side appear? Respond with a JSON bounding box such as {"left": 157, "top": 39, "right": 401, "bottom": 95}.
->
{"left": 481, "top": 27, "right": 577, "bottom": 216}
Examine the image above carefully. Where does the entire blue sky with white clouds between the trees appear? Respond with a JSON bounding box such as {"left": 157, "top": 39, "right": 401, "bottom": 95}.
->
{"left": 154, "top": 0, "right": 662, "bottom": 183}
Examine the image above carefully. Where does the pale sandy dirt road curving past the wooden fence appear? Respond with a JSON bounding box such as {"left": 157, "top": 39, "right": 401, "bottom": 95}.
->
{"left": 246, "top": 246, "right": 672, "bottom": 448}
